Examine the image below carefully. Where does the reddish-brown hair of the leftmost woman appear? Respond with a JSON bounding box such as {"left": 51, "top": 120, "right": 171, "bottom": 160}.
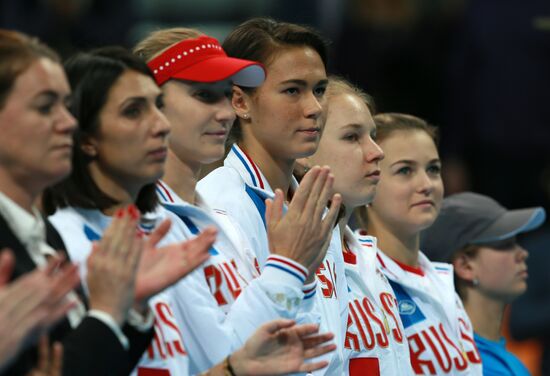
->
{"left": 0, "top": 29, "right": 61, "bottom": 109}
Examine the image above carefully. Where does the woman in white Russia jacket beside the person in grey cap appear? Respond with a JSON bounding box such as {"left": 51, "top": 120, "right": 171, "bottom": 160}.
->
{"left": 359, "top": 114, "right": 482, "bottom": 375}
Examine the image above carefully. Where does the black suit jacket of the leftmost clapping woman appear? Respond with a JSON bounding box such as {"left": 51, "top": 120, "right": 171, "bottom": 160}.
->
{"left": 0, "top": 215, "right": 153, "bottom": 376}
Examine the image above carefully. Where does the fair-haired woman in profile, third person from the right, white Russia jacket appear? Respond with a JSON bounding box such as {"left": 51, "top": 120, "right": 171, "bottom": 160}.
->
{"left": 299, "top": 77, "right": 413, "bottom": 376}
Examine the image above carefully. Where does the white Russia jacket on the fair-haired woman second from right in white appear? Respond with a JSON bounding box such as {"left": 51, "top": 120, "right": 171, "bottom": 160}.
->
{"left": 344, "top": 227, "right": 414, "bottom": 376}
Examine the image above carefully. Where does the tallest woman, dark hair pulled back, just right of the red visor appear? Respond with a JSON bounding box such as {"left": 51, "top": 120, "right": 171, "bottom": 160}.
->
{"left": 198, "top": 18, "right": 348, "bottom": 375}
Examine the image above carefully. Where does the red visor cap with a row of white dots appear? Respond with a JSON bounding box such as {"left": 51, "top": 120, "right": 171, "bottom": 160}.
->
{"left": 147, "top": 36, "right": 265, "bottom": 87}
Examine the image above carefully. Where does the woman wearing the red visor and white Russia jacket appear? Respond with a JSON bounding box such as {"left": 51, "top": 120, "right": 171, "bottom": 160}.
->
{"left": 134, "top": 28, "right": 336, "bottom": 373}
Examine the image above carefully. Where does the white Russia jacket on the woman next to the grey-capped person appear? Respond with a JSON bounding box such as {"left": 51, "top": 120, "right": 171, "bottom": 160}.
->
{"left": 356, "top": 231, "right": 483, "bottom": 375}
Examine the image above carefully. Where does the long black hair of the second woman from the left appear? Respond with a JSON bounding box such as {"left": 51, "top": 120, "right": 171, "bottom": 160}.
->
{"left": 42, "top": 47, "right": 158, "bottom": 214}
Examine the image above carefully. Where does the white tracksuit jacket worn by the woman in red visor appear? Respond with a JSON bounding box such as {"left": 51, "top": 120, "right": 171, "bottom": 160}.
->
{"left": 157, "top": 182, "right": 320, "bottom": 374}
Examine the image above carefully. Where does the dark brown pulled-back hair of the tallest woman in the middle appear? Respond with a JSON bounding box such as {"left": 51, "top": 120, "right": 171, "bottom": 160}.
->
{"left": 222, "top": 17, "right": 328, "bottom": 142}
